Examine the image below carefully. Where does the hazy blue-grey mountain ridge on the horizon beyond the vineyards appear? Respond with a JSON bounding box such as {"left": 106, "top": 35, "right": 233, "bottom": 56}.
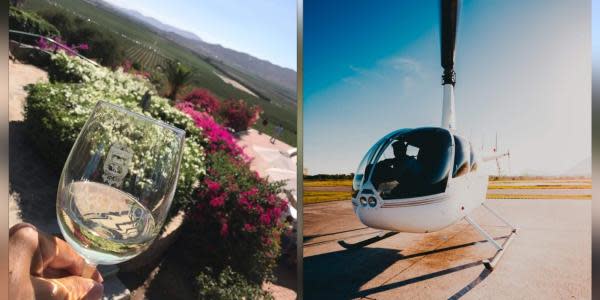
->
{"left": 86, "top": 0, "right": 297, "bottom": 96}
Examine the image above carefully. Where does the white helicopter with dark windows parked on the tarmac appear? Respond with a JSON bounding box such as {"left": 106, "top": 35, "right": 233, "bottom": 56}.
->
{"left": 339, "top": 0, "right": 517, "bottom": 270}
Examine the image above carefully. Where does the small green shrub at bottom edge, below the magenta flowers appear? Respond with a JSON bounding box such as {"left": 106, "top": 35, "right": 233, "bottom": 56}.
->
{"left": 197, "top": 267, "right": 273, "bottom": 300}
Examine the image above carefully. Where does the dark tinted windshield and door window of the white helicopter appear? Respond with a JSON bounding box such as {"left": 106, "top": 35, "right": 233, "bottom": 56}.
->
{"left": 366, "top": 128, "right": 454, "bottom": 199}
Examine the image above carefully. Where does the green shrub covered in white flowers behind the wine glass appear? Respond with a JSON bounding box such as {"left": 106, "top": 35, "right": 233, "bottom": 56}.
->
{"left": 25, "top": 53, "right": 205, "bottom": 212}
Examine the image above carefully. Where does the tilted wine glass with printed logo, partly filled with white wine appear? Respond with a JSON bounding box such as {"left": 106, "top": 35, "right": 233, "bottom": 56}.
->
{"left": 56, "top": 101, "right": 185, "bottom": 276}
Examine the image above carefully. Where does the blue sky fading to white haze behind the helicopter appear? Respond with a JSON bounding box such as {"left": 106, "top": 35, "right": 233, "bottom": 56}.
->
{"left": 303, "top": 0, "right": 591, "bottom": 174}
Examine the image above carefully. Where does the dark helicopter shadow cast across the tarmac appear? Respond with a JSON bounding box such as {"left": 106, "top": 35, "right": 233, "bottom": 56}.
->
{"left": 304, "top": 236, "right": 507, "bottom": 299}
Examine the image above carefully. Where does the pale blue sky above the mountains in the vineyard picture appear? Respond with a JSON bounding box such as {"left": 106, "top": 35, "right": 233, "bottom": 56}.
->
{"left": 107, "top": 0, "right": 297, "bottom": 70}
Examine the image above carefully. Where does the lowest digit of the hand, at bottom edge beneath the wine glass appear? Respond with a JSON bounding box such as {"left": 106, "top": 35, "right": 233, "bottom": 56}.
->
{"left": 31, "top": 276, "right": 104, "bottom": 300}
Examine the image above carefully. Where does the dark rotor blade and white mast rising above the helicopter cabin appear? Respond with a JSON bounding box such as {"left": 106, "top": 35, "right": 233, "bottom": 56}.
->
{"left": 440, "top": 0, "right": 459, "bottom": 132}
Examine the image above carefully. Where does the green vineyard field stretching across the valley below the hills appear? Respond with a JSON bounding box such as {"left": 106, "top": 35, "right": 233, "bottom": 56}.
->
{"left": 24, "top": 0, "right": 297, "bottom": 146}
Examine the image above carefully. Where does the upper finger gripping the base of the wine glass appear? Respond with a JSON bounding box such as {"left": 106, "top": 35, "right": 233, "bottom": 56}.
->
{"left": 38, "top": 232, "right": 103, "bottom": 282}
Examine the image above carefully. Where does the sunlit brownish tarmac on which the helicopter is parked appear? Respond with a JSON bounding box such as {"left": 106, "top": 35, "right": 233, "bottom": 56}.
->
{"left": 304, "top": 185, "right": 591, "bottom": 299}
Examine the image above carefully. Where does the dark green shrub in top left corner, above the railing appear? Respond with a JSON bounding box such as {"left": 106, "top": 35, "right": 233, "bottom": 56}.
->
{"left": 8, "top": 6, "right": 60, "bottom": 45}
